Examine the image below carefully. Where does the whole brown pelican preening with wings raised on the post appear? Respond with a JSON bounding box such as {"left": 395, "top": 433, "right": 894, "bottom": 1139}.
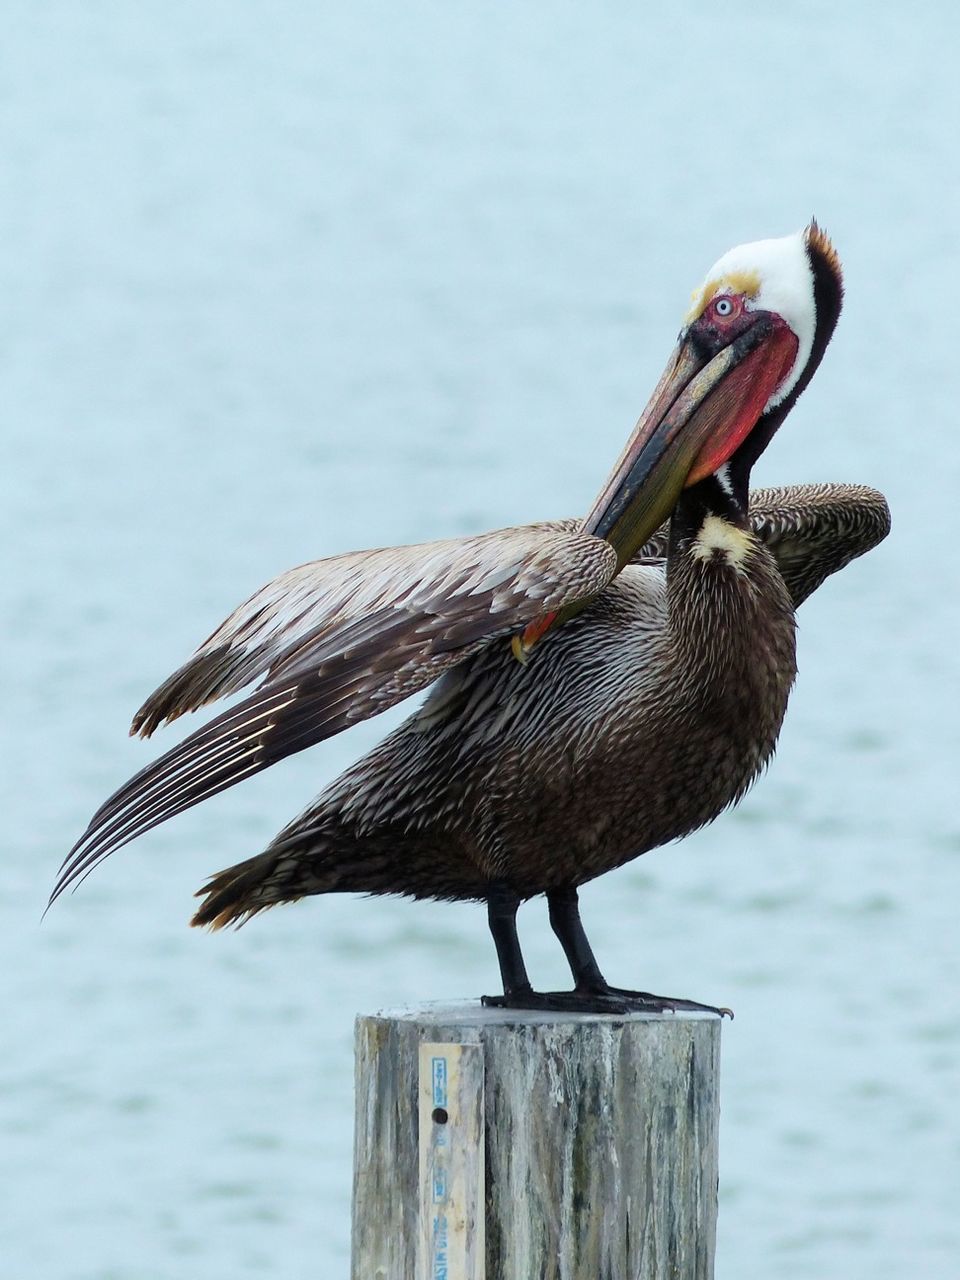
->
{"left": 51, "top": 223, "right": 890, "bottom": 1012}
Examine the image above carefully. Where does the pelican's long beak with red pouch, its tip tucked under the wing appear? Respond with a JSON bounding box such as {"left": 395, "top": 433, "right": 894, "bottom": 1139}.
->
{"left": 513, "top": 311, "right": 796, "bottom": 660}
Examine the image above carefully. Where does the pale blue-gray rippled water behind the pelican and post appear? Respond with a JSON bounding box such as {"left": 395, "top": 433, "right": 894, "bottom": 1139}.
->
{"left": 0, "top": 0, "right": 960, "bottom": 1280}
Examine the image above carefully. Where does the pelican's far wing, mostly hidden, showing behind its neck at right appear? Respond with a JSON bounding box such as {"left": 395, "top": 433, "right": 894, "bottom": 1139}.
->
{"left": 636, "top": 484, "right": 890, "bottom": 608}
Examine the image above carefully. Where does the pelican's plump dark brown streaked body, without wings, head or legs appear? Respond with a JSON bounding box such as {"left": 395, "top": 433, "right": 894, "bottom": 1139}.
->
{"left": 268, "top": 499, "right": 795, "bottom": 905}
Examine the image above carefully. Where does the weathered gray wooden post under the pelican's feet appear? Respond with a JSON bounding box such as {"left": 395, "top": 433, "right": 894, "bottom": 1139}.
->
{"left": 352, "top": 1002, "right": 721, "bottom": 1280}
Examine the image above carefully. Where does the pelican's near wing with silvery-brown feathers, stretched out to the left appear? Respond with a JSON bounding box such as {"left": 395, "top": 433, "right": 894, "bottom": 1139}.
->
{"left": 50, "top": 524, "right": 617, "bottom": 902}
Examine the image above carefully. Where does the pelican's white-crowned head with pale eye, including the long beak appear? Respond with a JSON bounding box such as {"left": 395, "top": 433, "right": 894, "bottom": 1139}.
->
{"left": 584, "top": 221, "right": 844, "bottom": 564}
